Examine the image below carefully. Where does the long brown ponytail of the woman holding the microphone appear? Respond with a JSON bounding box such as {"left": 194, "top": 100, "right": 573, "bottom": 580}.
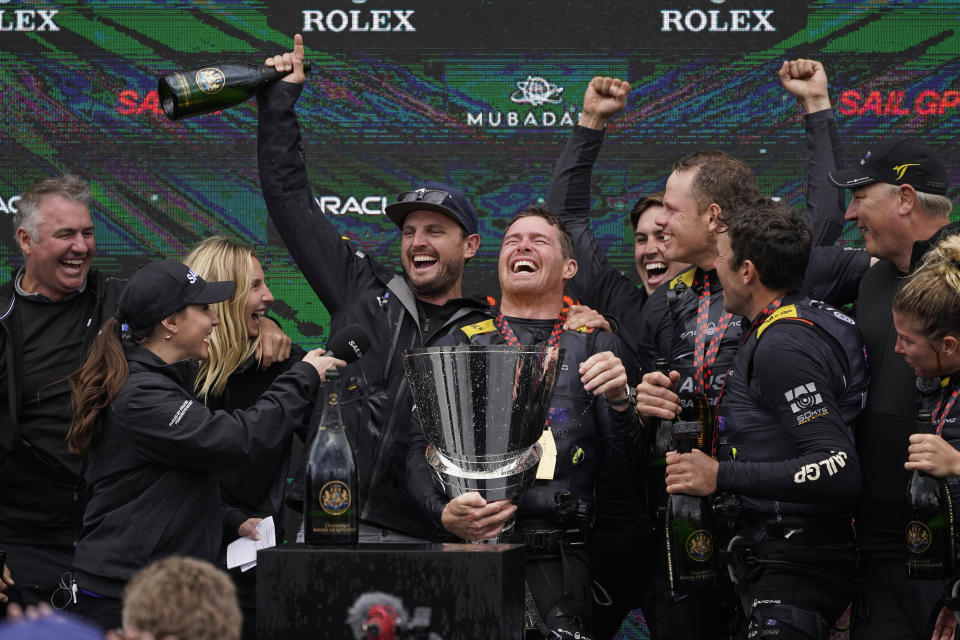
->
{"left": 67, "top": 309, "right": 157, "bottom": 454}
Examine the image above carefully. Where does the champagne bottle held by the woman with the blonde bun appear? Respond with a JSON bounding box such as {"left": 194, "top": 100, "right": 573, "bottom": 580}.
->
{"left": 904, "top": 410, "right": 956, "bottom": 580}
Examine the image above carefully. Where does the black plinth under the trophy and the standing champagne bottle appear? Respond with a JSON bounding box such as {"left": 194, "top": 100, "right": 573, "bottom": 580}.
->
{"left": 256, "top": 544, "right": 524, "bottom": 640}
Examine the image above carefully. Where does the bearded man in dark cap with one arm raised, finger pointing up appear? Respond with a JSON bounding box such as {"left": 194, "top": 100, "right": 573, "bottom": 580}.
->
{"left": 257, "top": 34, "right": 487, "bottom": 542}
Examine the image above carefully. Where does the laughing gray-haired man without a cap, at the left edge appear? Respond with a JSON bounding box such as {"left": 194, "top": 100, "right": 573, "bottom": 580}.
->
{"left": 0, "top": 174, "right": 123, "bottom": 604}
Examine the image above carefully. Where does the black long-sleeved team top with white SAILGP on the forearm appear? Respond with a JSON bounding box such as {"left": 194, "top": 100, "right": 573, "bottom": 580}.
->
{"left": 717, "top": 297, "right": 868, "bottom": 520}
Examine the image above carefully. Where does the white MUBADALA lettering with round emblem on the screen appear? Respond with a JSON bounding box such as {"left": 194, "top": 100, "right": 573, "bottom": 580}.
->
{"left": 467, "top": 75, "right": 579, "bottom": 128}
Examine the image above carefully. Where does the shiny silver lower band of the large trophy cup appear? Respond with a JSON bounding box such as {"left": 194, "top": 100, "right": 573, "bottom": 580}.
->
{"left": 427, "top": 443, "right": 543, "bottom": 501}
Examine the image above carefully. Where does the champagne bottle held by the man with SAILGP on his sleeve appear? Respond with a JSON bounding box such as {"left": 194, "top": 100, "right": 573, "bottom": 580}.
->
{"left": 665, "top": 421, "right": 717, "bottom": 592}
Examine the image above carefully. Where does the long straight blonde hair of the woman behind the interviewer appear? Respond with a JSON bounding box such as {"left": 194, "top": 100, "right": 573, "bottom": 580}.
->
{"left": 183, "top": 236, "right": 260, "bottom": 399}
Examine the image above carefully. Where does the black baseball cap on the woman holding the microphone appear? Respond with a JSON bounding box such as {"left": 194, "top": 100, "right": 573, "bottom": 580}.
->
{"left": 117, "top": 260, "right": 237, "bottom": 329}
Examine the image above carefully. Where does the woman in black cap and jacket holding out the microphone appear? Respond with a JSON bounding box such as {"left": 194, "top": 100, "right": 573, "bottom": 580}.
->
{"left": 67, "top": 260, "right": 345, "bottom": 629}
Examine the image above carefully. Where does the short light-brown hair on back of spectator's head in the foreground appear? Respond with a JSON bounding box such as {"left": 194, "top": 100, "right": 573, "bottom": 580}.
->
{"left": 123, "top": 556, "right": 243, "bottom": 640}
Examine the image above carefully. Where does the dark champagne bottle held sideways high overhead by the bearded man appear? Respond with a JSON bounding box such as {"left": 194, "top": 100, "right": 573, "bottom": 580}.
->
{"left": 157, "top": 61, "right": 310, "bottom": 120}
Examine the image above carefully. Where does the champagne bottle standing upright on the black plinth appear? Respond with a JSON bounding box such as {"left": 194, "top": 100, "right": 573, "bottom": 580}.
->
{"left": 303, "top": 370, "right": 360, "bottom": 545}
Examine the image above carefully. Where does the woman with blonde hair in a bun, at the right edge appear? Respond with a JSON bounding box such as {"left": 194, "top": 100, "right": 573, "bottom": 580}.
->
{"left": 893, "top": 236, "right": 960, "bottom": 639}
